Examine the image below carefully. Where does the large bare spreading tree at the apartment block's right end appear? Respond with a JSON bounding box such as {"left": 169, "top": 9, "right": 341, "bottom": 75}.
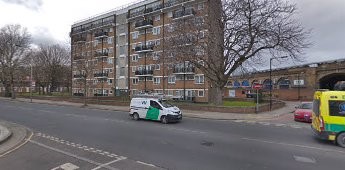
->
{"left": 166, "top": 0, "right": 310, "bottom": 105}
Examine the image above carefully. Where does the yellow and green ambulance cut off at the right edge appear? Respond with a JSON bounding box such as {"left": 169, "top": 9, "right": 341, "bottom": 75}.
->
{"left": 312, "top": 90, "right": 345, "bottom": 147}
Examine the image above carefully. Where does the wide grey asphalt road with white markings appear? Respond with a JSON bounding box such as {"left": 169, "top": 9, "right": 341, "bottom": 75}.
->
{"left": 0, "top": 100, "right": 345, "bottom": 170}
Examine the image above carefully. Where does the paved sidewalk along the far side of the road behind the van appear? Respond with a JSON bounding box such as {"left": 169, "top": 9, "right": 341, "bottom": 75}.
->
{"left": 0, "top": 97, "right": 299, "bottom": 121}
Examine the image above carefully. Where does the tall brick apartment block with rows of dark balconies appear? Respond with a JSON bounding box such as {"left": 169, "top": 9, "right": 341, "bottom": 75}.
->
{"left": 71, "top": 0, "right": 208, "bottom": 102}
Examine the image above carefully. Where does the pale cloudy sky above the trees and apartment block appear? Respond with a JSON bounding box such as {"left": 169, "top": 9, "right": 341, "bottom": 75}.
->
{"left": 0, "top": 0, "right": 345, "bottom": 65}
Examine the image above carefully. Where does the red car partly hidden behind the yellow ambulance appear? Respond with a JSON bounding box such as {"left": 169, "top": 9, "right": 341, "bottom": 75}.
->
{"left": 294, "top": 102, "right": 313, "bottom": 123}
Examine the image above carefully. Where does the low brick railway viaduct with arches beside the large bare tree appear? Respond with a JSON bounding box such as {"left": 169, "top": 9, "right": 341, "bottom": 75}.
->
{"left": 224, "top": 60, "right": 345, "bottom": 100}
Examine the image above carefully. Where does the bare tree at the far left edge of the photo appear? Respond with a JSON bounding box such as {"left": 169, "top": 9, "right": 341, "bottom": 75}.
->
{"left": 0, "top": 25, "right": 31, "bottom": 99}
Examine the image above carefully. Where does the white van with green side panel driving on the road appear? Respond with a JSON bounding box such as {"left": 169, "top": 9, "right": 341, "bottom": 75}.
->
{"left": 129, "top": 98, "right": 182, "bottom": 124}
